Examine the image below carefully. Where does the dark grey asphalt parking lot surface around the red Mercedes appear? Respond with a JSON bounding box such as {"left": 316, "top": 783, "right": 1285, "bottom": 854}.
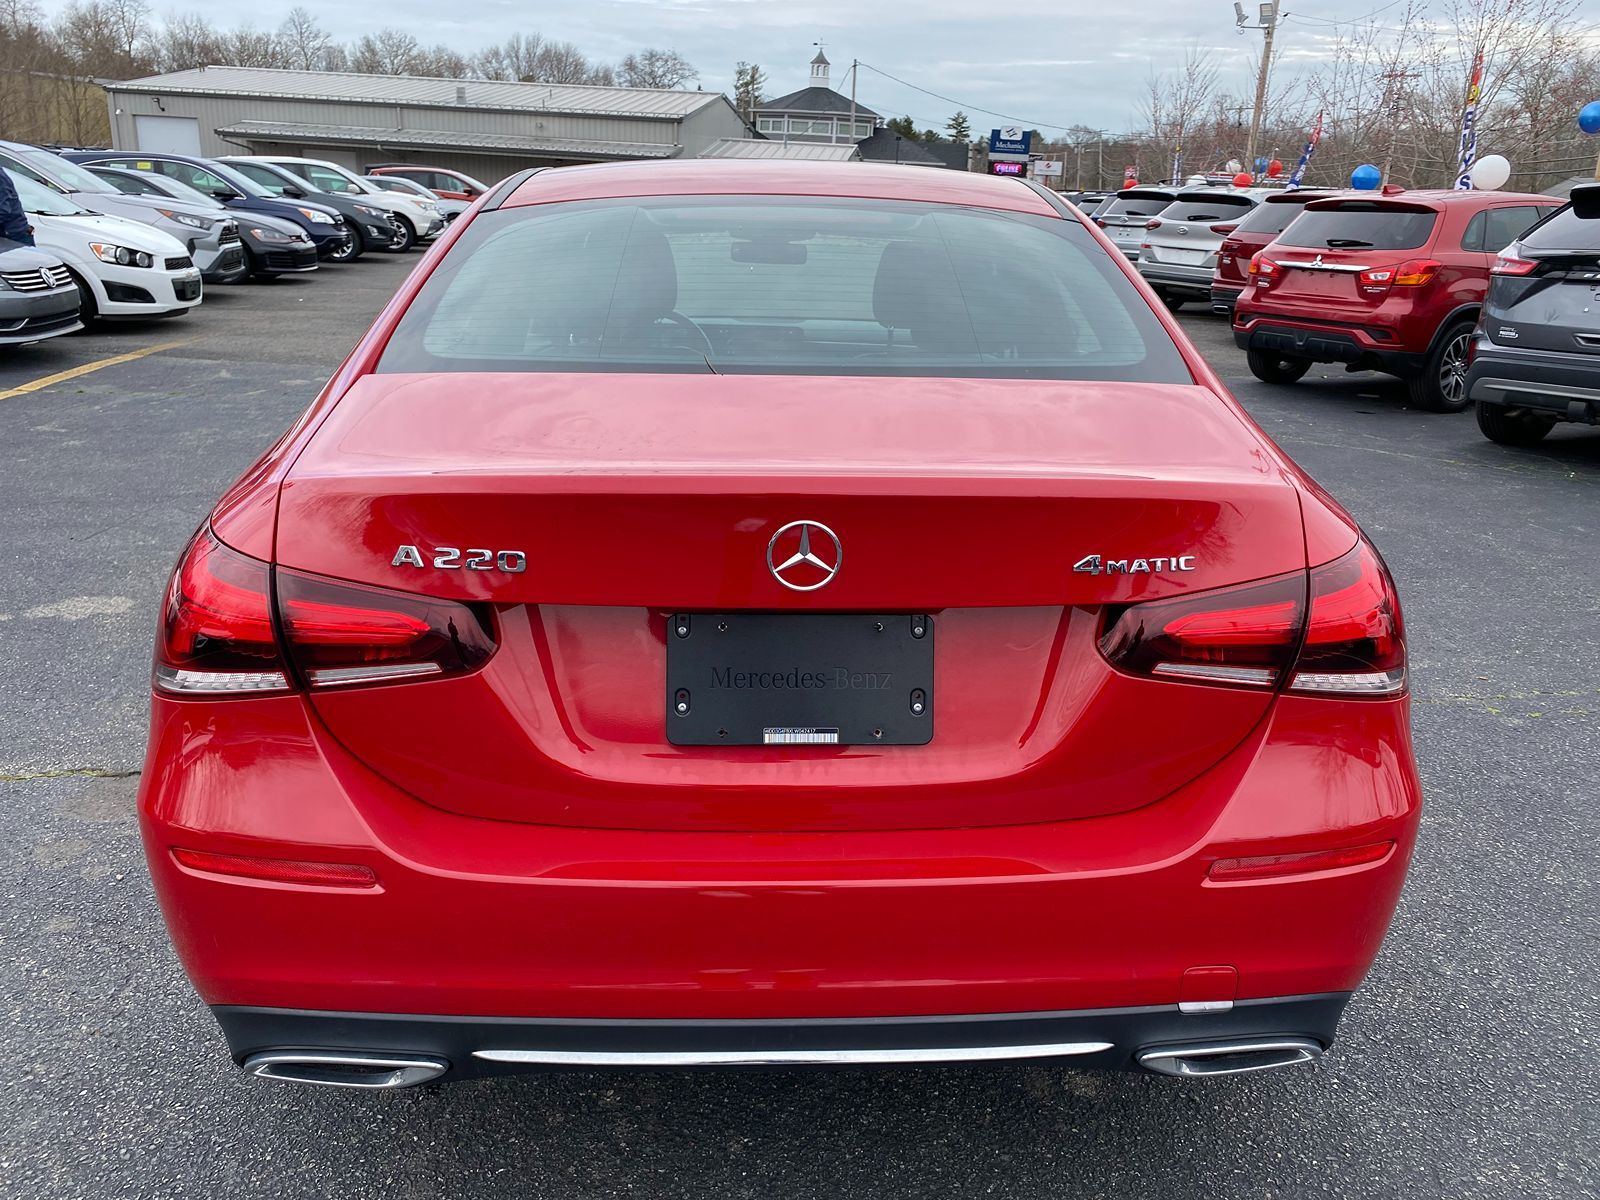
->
{"left": 0, "top": 256, "right": 1600, "bottom": 1200}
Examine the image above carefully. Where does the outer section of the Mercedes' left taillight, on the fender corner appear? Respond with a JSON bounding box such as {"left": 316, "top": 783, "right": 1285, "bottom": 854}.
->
{"left": 154, "top": 526, "right": 290, "bottom": 694}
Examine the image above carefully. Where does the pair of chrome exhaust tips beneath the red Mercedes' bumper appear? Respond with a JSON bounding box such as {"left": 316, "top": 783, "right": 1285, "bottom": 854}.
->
{"left": 245, "top": 1037, "right": 1323, "bottom": 1091}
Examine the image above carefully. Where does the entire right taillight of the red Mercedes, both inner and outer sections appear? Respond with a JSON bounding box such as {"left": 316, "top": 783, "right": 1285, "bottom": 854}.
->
{"left": 1099, "top": 541, "right": 1406, "bottom": 696}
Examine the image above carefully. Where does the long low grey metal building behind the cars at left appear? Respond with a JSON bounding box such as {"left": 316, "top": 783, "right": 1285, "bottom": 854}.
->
{"left": 106, "top": 67, "right": 750, "bottom": 181}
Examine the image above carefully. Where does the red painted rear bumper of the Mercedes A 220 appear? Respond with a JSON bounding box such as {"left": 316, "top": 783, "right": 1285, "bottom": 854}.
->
{"left": 139, "top": 684, "right": 1421, "bottom": 1021}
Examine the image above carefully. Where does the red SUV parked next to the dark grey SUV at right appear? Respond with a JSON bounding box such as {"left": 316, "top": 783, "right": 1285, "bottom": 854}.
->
{"left": 1234, "top": 192, "right": 1560, "bottom": 413}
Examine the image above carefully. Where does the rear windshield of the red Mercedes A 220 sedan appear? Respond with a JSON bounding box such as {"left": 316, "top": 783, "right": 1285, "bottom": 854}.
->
{"left": 378, "top": 197, "right": 1192, "bottom": 382}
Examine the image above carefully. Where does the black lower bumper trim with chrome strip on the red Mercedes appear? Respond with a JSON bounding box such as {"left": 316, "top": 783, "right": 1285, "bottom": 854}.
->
{"left": 211, "top": 992, "right": 1349, "bottom": 1080}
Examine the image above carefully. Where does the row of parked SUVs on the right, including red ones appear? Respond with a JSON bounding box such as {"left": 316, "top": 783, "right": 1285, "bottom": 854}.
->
{"left": 1085, "top": 178, "right": 1600, "bottom": 445}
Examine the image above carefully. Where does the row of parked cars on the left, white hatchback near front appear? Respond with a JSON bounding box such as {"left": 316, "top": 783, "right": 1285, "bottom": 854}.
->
{"left": 0, "top": 141, "right": 485, "bottom": 347}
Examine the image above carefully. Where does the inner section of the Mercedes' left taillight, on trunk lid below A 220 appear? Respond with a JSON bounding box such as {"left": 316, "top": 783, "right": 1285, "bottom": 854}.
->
{"left": 277, "top": 568, "right": 494, "bottom": 690}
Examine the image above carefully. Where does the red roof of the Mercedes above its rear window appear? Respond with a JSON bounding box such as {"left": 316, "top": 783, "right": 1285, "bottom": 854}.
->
{"left": 501, "top": 158, "right": 1058, "bottom": 216}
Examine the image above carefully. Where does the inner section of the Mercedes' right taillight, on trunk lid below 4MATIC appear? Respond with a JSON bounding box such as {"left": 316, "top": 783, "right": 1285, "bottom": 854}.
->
{"left": 1099, "top": 571, "right": 1306, "bottom": 688}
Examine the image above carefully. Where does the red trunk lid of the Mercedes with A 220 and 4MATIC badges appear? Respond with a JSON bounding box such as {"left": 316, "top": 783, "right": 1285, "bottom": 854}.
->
{"left": 277, "top": 373, "right": 1306, "bottom": 830}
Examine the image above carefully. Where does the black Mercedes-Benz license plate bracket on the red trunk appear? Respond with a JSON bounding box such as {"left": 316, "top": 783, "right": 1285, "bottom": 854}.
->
{"left": 666, "top": 613, "right": 933, "bottom": 746}
